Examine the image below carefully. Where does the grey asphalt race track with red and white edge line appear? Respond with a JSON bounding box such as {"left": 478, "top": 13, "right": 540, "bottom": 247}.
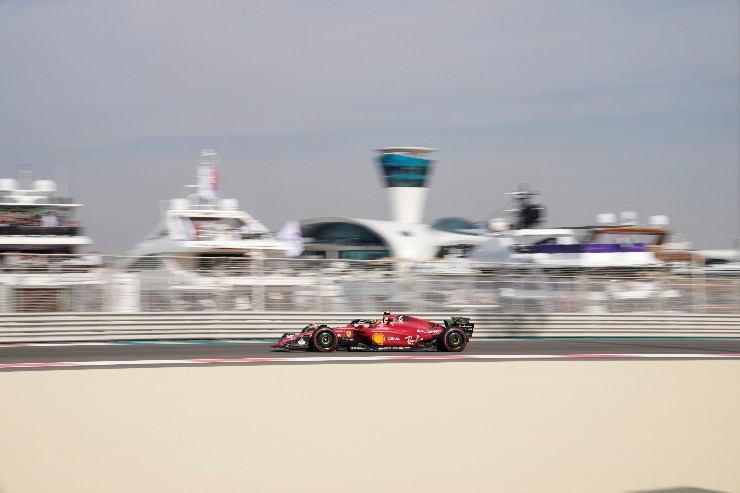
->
{"left": 0, "top": 339, "right": 740, "bottom": 371}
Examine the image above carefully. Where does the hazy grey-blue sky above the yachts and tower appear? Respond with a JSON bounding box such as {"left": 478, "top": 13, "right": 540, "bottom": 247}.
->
{"left": 0, "top": 0, "right": 740, "bottom": 253}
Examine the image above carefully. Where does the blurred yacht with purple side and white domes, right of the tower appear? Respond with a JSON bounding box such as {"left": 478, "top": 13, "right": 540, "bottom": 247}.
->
{"left": 456, "top": 187, "right": 697, "bottom": 312}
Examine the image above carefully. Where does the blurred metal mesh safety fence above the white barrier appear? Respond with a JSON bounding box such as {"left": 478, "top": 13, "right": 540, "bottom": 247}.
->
{"left": 0, "top": 255, "right": 740, "bottom": 314}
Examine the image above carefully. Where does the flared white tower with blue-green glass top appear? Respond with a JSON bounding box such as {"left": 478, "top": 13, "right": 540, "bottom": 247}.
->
{"left": 378, "top": 147, "right": 436, "bottom": 224}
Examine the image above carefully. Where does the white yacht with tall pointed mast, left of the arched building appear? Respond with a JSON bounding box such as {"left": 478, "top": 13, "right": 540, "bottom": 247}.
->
{"left": 123, "top": 149, "right": 312, "bottom": 310}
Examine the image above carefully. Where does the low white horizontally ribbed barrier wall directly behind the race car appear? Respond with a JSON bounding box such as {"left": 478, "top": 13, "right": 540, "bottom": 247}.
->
{"left": 0, "top": 311, "right": 740, "bottom": 344}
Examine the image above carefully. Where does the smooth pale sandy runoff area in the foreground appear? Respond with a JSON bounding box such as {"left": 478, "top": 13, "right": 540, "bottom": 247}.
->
{"left": 0, "top": 361, "right": 740, "bottom": 493}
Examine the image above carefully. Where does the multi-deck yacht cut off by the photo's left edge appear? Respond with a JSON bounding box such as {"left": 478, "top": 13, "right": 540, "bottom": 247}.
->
{"left": 0, "top": 170, "right": 99, "bottom": 312}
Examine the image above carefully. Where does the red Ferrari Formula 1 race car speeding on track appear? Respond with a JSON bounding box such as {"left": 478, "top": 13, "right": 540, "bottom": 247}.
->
{"left": 272, "top": 313, "right": 474, "bottom": 353}
